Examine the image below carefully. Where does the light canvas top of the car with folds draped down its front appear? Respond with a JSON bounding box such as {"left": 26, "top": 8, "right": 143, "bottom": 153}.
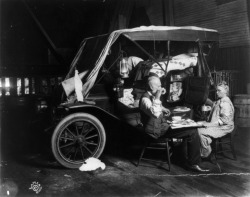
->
{"left": 62, "top": 26, "right": 219, "bottom": 98}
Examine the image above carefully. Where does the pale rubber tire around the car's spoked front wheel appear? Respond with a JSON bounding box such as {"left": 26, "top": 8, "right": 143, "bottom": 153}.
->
{"left": 51, "top": 113, "right": 106, "bottom": 169}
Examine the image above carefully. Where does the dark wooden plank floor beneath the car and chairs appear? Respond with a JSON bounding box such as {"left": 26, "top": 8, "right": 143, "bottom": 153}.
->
{"left": 1, "top": 128, "right": 250, "bottom": 197}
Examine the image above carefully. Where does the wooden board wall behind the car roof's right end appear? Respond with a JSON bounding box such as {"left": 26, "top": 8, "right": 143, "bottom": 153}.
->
{"left": 174, "top": 0, "right": 250, "bottom": 87}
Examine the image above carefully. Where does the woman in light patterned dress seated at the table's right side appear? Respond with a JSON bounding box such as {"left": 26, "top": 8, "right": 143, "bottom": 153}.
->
{"left": 198, "top": 81, "right": 234, "bottom": 157}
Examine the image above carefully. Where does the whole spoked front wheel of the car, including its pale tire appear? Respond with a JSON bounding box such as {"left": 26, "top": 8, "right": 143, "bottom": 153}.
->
{"left": 51, "top": 113, "right": 106, "bottom": 168}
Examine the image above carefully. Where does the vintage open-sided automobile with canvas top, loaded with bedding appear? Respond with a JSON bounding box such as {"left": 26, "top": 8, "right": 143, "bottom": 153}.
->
{"left": 51, "top": 26, "right": 219, "bottom": 168}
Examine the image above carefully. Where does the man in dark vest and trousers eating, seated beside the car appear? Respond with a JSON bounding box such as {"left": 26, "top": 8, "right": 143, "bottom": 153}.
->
{"left": 139, "top": 76, "right": 209, "bottom": 172}
